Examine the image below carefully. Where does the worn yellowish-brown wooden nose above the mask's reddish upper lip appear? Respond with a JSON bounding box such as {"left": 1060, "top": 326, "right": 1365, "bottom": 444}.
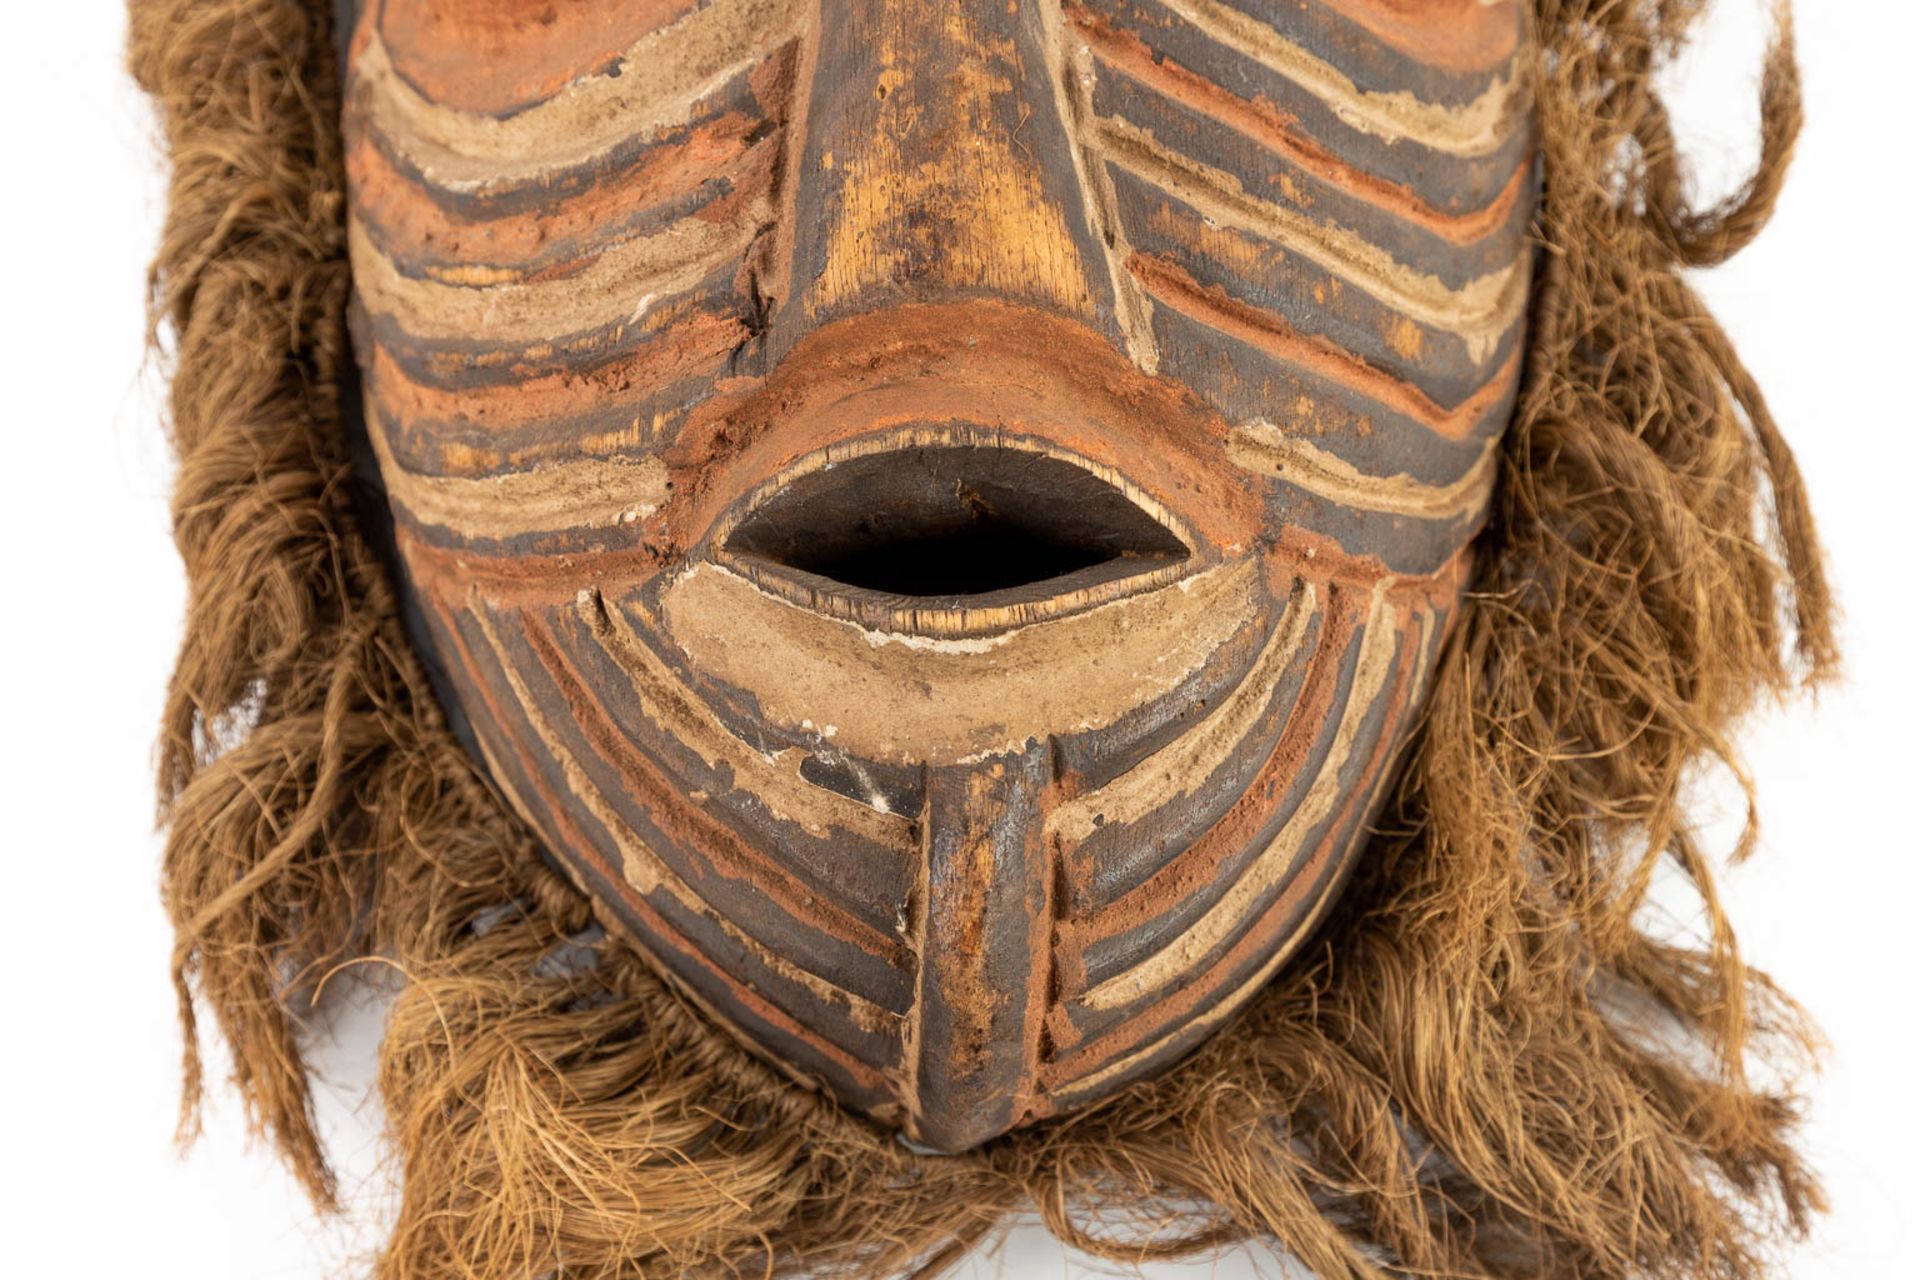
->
{"left": 764, "top": 0, "right": 1119, "bottom": 363}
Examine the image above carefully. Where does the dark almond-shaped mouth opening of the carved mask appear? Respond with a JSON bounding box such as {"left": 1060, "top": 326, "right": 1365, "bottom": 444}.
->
{"left": 724, "top": 445, "right": 1188, "bottom": 604}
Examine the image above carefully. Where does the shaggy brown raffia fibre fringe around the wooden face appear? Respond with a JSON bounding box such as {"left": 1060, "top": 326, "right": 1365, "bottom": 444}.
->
{"left": 132, "top": 0, "right": 1834, "bottom": 1280}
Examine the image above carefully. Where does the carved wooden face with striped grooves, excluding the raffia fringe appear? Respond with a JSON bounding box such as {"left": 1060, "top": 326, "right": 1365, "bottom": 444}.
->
{"left": 346, "top": 0, "right": 1534, "bottom": 1150}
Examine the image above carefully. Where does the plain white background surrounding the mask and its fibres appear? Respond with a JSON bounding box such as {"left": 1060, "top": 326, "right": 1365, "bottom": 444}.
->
{"left": 0, "top": 0, "right": 1920, "bottom": 1280}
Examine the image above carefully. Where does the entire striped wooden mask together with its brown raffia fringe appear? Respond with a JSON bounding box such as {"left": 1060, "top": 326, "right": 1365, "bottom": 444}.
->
{"left": 131, "top": 0, "right": 1834, "bottom": 1280}
